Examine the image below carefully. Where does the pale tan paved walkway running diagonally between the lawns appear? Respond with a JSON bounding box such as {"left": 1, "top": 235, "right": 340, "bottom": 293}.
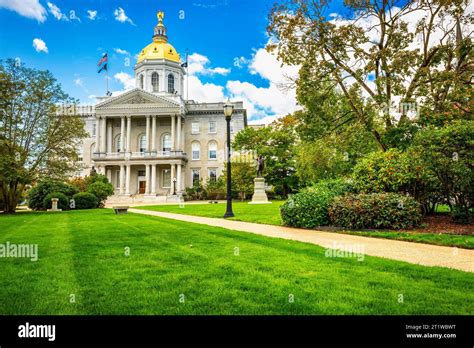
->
{"left": 129, "top": 209, "right": 474, "bottom": 272}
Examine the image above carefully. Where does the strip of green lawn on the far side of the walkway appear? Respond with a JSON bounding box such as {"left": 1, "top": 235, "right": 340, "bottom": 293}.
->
{"left": 137, "top": 201, "right": 474, "bottom": 249}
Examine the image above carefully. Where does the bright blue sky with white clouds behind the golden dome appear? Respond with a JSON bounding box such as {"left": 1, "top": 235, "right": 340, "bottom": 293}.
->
{"left": 0, "top": 0, "right": 346, "bottom": 120}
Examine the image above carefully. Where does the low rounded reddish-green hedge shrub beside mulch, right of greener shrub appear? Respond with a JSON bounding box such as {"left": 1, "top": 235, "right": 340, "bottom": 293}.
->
{"left": 329, "top": 193, "right": 421, "bottom": 229}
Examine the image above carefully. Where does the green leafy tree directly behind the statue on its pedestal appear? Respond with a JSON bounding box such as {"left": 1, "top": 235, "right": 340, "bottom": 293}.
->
{"left": 233, "top": 115, "right": 298, "bottom": 196}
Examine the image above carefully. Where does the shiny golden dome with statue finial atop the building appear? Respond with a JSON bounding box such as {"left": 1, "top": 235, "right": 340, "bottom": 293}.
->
{"left": 137, "top": 12, "right": 180, "bottom": 64}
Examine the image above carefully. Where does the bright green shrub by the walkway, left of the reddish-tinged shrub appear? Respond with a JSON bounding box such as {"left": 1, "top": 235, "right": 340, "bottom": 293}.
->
{"left": 280, "top": 179, "right": 350, "bottom": 228}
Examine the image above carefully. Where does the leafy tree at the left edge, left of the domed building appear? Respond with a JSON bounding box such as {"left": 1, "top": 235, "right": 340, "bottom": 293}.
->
{"left": 0, "top": 59, "right": 86, "bottom": 213}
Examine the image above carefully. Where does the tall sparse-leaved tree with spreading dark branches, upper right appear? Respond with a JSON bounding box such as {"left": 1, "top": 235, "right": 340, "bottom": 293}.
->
{"left": 267, "top": 0, "right": 473, "bottom": 150}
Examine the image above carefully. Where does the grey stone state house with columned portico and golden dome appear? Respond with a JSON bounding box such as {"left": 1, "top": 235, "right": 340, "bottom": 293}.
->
{"left": 75, "top": 12, "right": 247, "bottom": 201}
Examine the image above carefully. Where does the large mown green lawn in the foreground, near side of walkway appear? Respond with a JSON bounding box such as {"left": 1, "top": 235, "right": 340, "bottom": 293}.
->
{"left": 0, "top": 209, "right": 474, "bottom": 315}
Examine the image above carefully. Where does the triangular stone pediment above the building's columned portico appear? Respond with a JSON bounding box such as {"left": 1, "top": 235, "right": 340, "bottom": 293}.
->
{"left": 96, "top": 88, "right": 181, "bottom": 110}
